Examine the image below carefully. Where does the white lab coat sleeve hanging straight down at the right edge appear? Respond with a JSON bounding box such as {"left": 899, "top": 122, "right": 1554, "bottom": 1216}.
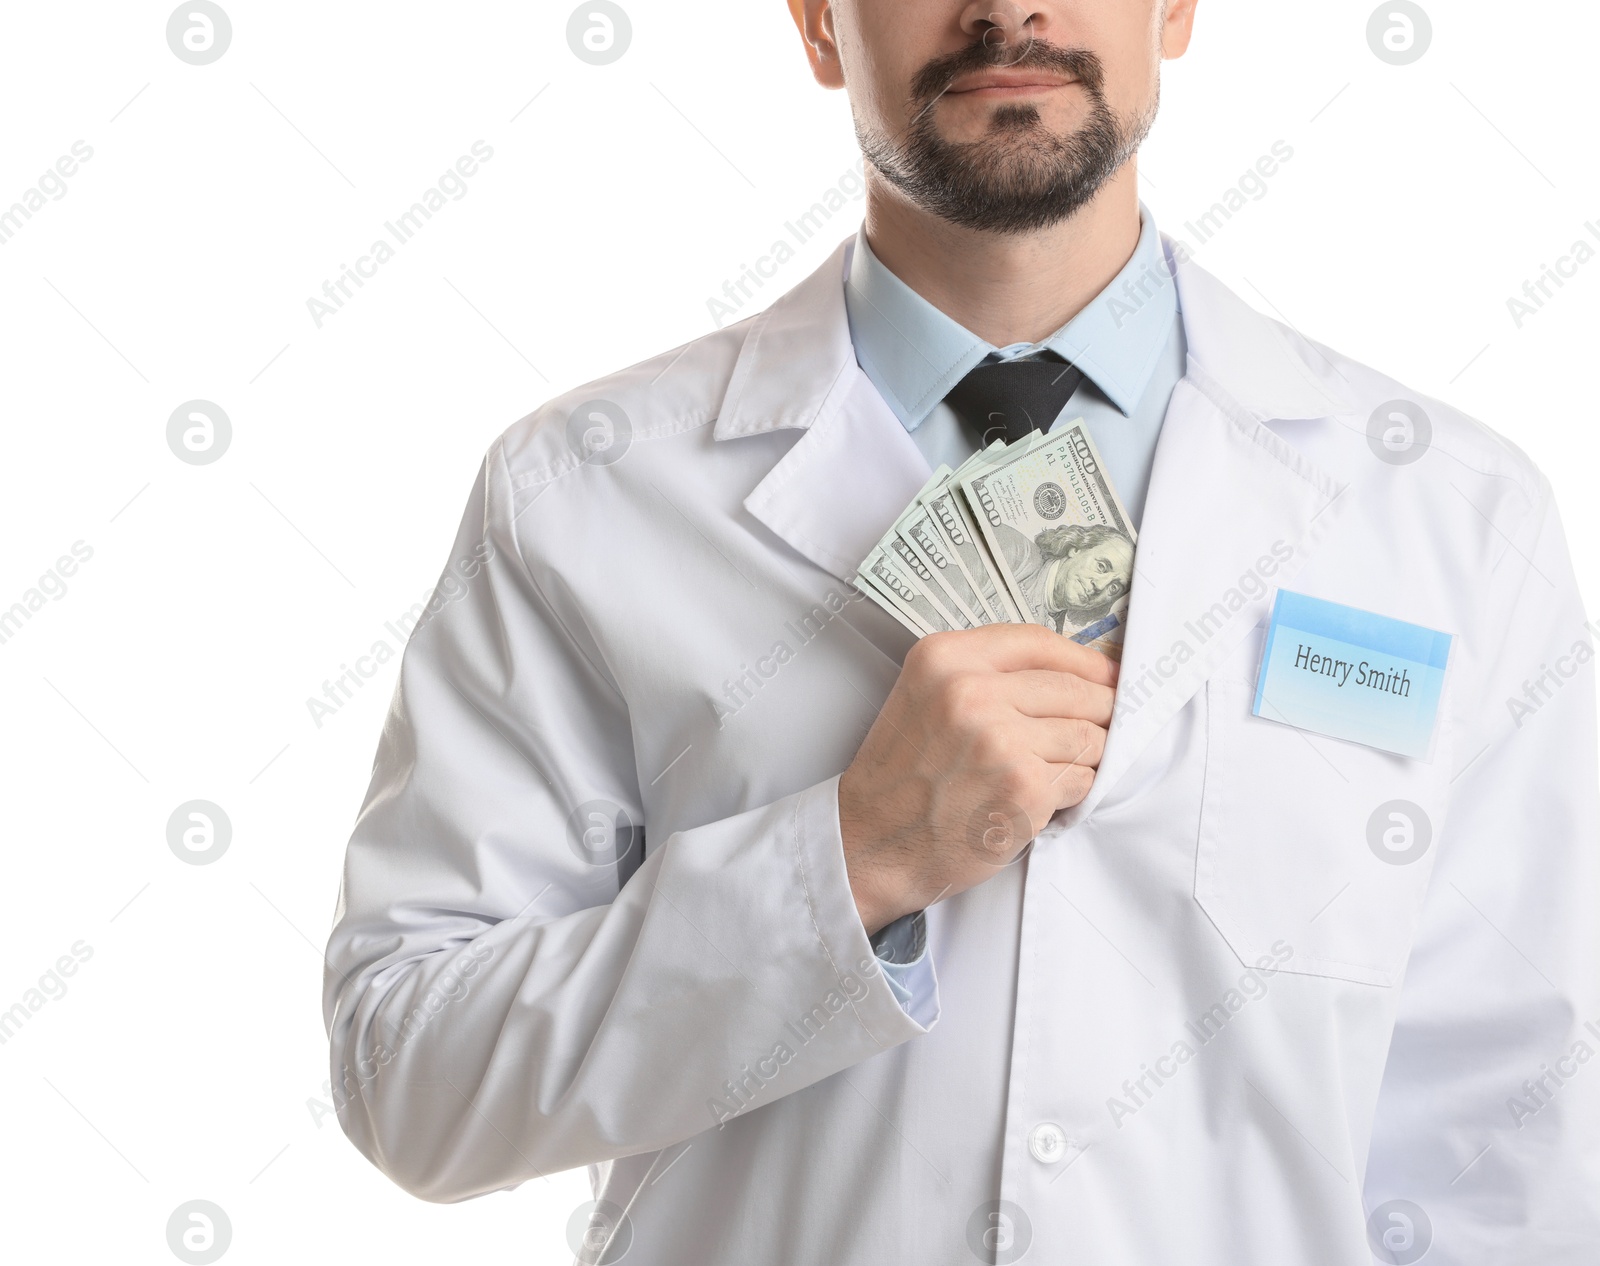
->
{"left": 1365, "top": 480, "right": 1600, "bottom": 1266}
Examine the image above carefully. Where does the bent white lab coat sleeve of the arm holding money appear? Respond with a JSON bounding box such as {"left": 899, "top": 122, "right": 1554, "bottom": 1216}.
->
{"left": 323, "top": 443, "right": 926, "bottom": 1202}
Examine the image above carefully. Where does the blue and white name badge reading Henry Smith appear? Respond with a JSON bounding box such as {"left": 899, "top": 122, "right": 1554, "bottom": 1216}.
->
{"left": 1251, "top": 589, "right": 1454, "bottom": 760}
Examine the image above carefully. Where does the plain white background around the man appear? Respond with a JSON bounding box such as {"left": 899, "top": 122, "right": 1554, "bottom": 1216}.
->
{"left": 0, "top": 0, "right": 1600, "bottom": 1263}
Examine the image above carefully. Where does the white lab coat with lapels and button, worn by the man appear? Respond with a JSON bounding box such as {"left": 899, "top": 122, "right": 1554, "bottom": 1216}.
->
{"left": 325, "top": 232, "right": 1600, "bottom": 1266}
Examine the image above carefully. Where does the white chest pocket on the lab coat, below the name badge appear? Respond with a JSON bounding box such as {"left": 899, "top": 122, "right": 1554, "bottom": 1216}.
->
{"left": 1195, "top": 666, "right": 1448, "bottom": 986}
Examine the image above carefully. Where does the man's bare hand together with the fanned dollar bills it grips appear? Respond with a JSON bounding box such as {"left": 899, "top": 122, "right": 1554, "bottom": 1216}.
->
{"left": 838, "top": 419, "right": 1136, "bottom": 935}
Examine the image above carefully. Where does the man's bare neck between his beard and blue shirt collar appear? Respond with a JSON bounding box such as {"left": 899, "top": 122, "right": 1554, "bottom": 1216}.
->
{"left": 866, "top": 158, "right": 1139, "bottom": 347}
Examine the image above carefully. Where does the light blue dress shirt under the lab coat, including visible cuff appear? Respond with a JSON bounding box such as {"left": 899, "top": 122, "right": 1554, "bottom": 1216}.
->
{"left": 845, "top": 203, "right": 1187, "bottom": 998}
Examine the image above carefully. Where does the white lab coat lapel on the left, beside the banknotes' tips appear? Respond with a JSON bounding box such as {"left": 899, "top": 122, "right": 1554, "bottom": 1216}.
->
{"left": 715, "top": 238, "right": 931, "bottom": 581}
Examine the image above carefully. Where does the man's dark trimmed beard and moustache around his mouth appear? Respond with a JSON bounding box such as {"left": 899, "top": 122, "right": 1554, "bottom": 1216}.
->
{"left": 856, "top": 40, "right": 1160, "bottom": 234}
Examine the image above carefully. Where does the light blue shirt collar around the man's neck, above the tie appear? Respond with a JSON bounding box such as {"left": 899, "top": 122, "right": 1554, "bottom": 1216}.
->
{"left": 845, "top": 203, "right": 1178, "bottom": 431}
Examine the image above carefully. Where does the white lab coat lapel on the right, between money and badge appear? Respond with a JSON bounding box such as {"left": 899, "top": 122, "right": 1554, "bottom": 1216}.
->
{"left": 1058, "top": 243, "right": 1354, "bottom": 826}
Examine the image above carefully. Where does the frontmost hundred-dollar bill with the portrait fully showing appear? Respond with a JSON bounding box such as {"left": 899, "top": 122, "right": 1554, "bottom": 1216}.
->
{"left": 962, "top": 421, "right": 1138, "bottom": 650}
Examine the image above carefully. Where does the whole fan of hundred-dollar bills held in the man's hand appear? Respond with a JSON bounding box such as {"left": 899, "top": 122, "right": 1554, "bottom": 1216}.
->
{"left": 856, "top": 418, "right": 1138, "bottom": 659}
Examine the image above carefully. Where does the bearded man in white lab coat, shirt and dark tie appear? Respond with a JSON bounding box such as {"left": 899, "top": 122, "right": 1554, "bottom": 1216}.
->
{"left": 325, "top": 0, "right": 1600, "bottom": 1266}
